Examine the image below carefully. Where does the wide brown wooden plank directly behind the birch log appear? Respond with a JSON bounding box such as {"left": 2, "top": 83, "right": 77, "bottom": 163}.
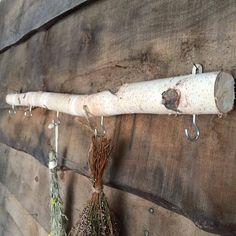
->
{"left": 0, "top": 0, "right": 236, "bottom": 232}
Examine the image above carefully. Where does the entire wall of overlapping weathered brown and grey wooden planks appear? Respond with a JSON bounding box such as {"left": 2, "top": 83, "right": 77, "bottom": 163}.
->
{"left": 0, "top": 0, "right": 236, "bottom": 235}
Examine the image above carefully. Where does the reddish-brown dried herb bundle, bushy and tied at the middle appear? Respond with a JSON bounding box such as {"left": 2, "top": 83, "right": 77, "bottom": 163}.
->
{"left": 69, "top": 136, "right": 118, "bottom": 236}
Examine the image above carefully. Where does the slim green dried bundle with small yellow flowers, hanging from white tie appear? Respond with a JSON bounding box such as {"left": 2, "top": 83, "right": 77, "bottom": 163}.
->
{"left": 49, "top": 151, "right": 67, "bottom": 236}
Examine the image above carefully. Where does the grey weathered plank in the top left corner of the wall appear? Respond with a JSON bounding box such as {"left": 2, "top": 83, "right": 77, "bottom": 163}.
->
{"left": 0, "top": 0, "right": 91, "bottom": 52}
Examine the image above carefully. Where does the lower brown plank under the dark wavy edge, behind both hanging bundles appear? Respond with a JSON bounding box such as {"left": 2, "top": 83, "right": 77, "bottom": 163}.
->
{"left": 0, "top": 144, "right": 218, "bottom": 236}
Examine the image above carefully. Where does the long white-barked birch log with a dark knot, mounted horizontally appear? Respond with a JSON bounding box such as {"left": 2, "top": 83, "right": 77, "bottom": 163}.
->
{"left": 6, "top": 72, "right": 234, "bottom": 116}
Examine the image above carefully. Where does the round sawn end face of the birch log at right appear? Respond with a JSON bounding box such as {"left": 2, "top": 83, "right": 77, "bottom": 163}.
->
{"left": 215, "top": 72, "right": 235, "bottom": 113}
